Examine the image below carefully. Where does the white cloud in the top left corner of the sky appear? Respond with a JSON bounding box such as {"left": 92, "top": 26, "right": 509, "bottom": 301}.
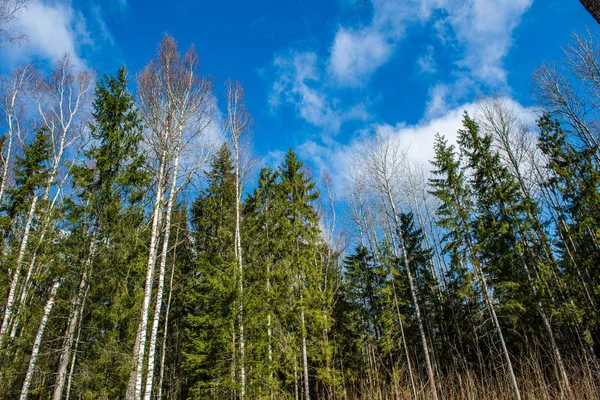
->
{"left": 2, "top": 0, "right": 93, "bottom": 67}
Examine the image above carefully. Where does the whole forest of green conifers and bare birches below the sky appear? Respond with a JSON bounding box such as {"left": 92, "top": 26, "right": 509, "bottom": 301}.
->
{"left": 0, "top": 0, "right": 600, "bottom": 400}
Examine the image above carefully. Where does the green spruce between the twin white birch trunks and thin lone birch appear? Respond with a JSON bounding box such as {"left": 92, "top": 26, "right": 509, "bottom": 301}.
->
{"left": 184, "top": 145, "right": 237, "bottom": 398}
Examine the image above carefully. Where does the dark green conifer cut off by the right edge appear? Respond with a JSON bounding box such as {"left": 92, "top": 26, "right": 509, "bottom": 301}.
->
{"left": 538, "top": 115, "right": 600, "bottom": 353}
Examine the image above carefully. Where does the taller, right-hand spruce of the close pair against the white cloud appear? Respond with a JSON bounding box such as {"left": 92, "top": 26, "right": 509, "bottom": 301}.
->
{"left": 459, "top": 113, "right": 571, "bottom": 394}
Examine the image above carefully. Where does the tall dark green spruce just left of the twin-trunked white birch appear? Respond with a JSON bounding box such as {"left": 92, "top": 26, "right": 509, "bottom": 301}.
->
{"left": 58, "top": 68, "right": 148, "bottom": 400}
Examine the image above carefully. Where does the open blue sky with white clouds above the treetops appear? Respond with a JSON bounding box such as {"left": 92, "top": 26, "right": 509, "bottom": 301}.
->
{"left": 0, "top": 0, "right": 599, "bottom": 197}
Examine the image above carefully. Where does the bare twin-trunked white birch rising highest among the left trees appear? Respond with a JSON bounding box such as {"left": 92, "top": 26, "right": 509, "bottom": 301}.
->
{"left": 126, "top": 36, "right": 212, "bottom": 399}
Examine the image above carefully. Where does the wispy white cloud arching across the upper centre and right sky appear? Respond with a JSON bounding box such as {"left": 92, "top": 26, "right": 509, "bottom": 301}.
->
{"left": 270, "top": 0, "right": 533, "bottom": 132}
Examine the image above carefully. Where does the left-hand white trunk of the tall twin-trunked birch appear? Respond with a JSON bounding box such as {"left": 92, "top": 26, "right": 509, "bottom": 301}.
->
{"left": 125, "top": 150, "right": 167, "bottom": 400}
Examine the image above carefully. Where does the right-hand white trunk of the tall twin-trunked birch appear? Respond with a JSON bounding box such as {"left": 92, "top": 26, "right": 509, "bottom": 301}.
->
{"left": 144, "top": 146, "right": 179, "bottom": 400}
